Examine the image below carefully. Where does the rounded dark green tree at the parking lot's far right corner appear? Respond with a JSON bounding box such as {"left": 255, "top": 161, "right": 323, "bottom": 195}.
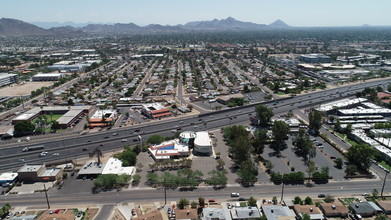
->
{"left": 346, "top": 144, "right": 374, "bottom": 171}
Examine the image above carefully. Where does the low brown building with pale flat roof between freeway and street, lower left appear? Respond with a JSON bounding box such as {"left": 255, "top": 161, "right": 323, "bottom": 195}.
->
{"left": 18, "top": 164, "right": 62, "bottom": 182}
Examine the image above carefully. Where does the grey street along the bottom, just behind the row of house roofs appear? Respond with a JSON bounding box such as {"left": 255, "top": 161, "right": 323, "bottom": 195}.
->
{"left": 0, "top": 178, "right": 391, "bottom": 207}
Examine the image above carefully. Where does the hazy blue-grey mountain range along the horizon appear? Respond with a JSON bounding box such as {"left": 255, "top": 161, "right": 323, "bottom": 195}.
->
{"left": 0, "top": 17, "right": 290, "bottom": 37}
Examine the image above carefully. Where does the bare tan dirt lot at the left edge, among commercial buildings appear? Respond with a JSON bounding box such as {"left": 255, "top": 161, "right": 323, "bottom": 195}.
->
{"left": 0, "top": 82, "right": 53, "bottom": 96}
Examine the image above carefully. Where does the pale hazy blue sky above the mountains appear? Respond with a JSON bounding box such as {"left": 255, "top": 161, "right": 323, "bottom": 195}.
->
{"left": 0, "top": 0, "right": 391, "bottom": 26}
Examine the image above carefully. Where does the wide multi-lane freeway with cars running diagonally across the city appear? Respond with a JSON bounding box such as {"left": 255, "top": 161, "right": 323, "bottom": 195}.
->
{"left": 0, "top": 80, "right": 391, "bottom": 171}
